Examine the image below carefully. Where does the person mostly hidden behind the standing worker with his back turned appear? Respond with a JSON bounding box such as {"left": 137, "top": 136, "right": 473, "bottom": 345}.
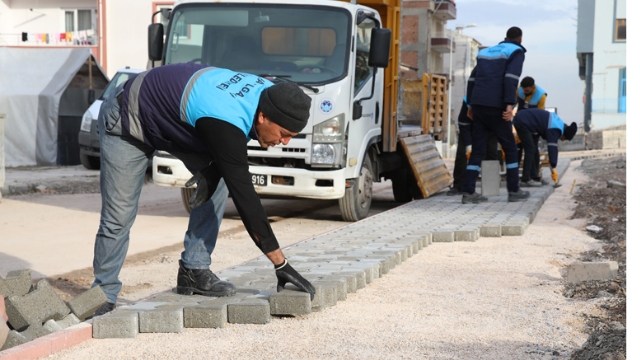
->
{"left": 447, "top": 96, "right": 499, "bottom": 196}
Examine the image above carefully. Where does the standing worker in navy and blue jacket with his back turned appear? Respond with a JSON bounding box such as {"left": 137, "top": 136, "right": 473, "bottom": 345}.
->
{"left": 462, "top": 26, "right": 529, "bottom": 204}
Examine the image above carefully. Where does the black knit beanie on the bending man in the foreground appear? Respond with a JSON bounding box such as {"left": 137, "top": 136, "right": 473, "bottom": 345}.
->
{"left": 258, "top": 82, "right": 311, "bottom": 133}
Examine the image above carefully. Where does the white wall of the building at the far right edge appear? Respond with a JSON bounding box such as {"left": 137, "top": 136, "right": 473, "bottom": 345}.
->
{"left": 591, "top": 0, "right": 627, "bottom": 130}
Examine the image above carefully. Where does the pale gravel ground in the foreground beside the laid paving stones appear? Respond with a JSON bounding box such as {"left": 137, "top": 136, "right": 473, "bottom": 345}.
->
{"left": 40, "top": 162, "right": 620, "bottom": 359}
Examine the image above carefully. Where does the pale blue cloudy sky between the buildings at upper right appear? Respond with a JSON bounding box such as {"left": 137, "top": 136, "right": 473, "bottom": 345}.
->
{"left": 446, "top": 0, "right": 584, "bottom": 124}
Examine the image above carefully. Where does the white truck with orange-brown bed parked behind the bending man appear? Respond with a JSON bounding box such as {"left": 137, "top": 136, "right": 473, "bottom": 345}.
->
{"left": 149, "top": 0, "right": 452, "bottom": 221}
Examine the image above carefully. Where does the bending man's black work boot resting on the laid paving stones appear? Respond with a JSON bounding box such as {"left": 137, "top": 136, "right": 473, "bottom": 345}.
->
{"left": 177, "top": 260, "right": 236, "bottom": 297}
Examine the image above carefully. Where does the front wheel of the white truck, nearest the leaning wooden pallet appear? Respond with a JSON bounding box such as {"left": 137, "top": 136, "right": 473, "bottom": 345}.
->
{"left": 338, "top": 154, "right": 373, "bottom": 221}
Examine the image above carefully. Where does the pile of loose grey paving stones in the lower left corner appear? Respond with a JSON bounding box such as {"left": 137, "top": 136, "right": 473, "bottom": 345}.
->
{"left": 0, "top": 269, "right": 107, "bottom": 351}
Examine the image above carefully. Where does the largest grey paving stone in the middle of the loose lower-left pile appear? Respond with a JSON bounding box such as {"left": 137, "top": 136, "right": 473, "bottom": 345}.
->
{"left": 6, "top": 279, "right": 70, "bottom": 330}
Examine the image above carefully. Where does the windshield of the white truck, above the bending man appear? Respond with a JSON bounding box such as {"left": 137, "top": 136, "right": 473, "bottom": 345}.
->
{"left": 165, "top": 3, "right": 351, "bottom": 84}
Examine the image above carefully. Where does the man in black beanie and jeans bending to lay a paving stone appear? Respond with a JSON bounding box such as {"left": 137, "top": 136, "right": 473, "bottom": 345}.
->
{"left": 93, "top": 63, "right": 315, "bottom": 315}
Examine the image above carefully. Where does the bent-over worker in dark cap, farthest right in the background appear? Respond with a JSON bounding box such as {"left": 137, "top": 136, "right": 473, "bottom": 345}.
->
{"left": 513, "top": 109, "right": 578, "bottom": 184}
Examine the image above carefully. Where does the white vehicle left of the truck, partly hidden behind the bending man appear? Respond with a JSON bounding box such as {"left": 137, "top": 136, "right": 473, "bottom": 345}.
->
{"left": 78, "top": 66, "right": 144, "bottom": 170}
